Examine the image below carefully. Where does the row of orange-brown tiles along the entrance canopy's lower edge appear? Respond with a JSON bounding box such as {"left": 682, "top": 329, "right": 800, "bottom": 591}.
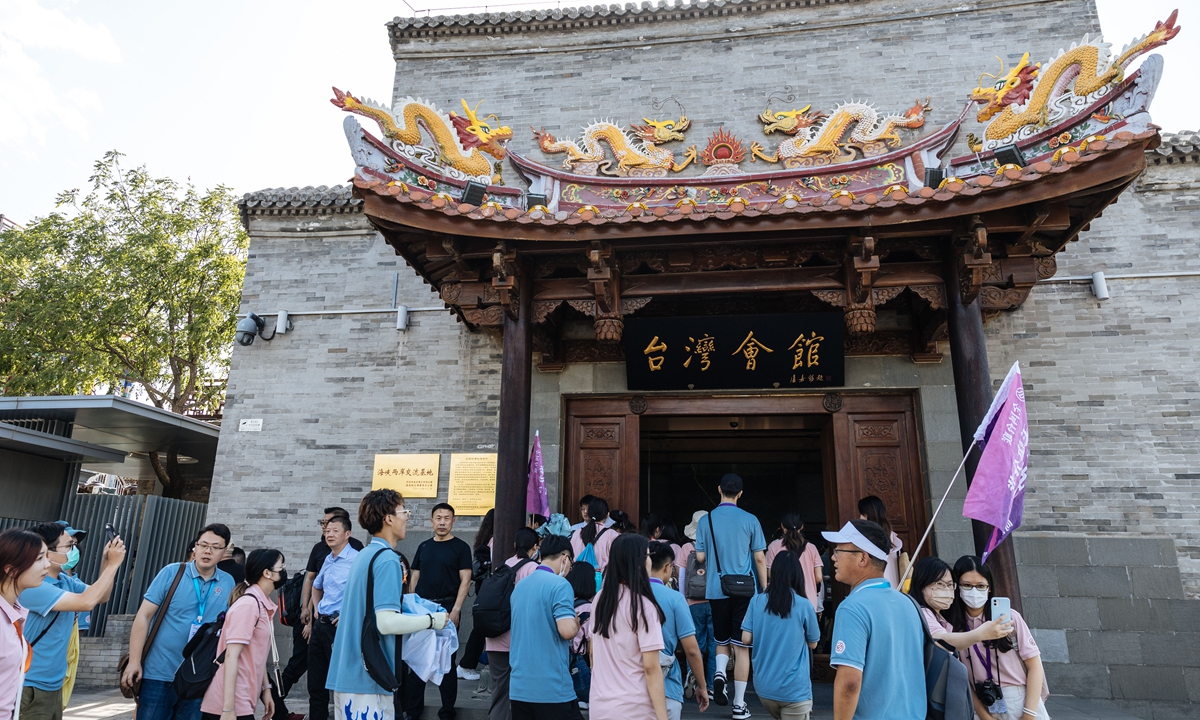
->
{"left": 354, "top": 128, "right": 1158, "bottom": 226}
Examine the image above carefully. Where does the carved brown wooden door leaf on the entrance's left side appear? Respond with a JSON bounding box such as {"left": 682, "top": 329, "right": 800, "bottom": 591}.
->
{"left": 563, "top": 398, "right": 641, "bottom": 522}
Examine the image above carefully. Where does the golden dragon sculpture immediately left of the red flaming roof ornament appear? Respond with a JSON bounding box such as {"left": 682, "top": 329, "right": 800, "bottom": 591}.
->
{"left": 530, "top": 116, "right": 696, "bottom": 178}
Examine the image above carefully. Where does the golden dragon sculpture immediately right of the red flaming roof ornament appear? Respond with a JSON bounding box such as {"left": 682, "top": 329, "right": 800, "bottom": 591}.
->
{"left": 750, "top": 98, "right": 930, "bottom": 167}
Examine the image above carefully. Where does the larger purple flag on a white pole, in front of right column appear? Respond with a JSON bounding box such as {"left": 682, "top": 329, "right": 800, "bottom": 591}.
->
{"left": 962, "top": 362, "right": 1030, "bottom": 562}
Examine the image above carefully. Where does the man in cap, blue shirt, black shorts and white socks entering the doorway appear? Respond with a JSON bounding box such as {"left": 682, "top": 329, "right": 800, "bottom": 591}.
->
{"left": 696, "top": 473, "right": 767, "bottom": 720}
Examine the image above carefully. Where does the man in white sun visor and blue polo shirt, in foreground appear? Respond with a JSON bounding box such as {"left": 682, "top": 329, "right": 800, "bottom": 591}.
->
{"left": 821, "top": 520, "right": 925, "bottom": 720}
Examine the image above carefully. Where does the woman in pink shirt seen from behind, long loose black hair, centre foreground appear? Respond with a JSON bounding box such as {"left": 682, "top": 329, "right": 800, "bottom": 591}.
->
{"left": 589, "top": 534, "right": 667, "bottom": 720}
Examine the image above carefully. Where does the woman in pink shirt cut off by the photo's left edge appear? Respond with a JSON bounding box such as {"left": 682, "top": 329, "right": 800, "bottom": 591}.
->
{"left": 0, "top": 528, "right": 50, "bottom": 720}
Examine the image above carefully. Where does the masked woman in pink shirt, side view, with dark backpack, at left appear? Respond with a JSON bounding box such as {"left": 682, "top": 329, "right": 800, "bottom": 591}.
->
{"left": 200, "top": 550, "right": 288, "bottom": 720}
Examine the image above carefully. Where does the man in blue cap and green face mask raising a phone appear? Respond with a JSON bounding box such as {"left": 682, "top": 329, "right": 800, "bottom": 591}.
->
{"left": 18, "top": 522, "right": 125, "bottom": 720}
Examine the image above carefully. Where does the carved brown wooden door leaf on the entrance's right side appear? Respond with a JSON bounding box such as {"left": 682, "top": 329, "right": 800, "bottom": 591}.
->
{"left": 833, "top": 397, "right": 929, "bottom": 560}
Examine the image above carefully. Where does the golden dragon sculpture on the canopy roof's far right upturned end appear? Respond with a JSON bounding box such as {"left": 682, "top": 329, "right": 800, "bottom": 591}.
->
{"left": 968, "top": 10, "right": 1180, "bottom": 151}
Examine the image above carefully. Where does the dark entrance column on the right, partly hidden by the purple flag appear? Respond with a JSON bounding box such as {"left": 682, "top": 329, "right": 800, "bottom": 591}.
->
{"left": 945, "top": 257, "right": 1021, "bottom": 611}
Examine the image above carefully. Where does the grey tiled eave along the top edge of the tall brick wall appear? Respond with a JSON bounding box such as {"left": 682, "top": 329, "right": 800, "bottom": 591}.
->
{"left": 388, "top": 0, "right": 858, "bottom": 35}
